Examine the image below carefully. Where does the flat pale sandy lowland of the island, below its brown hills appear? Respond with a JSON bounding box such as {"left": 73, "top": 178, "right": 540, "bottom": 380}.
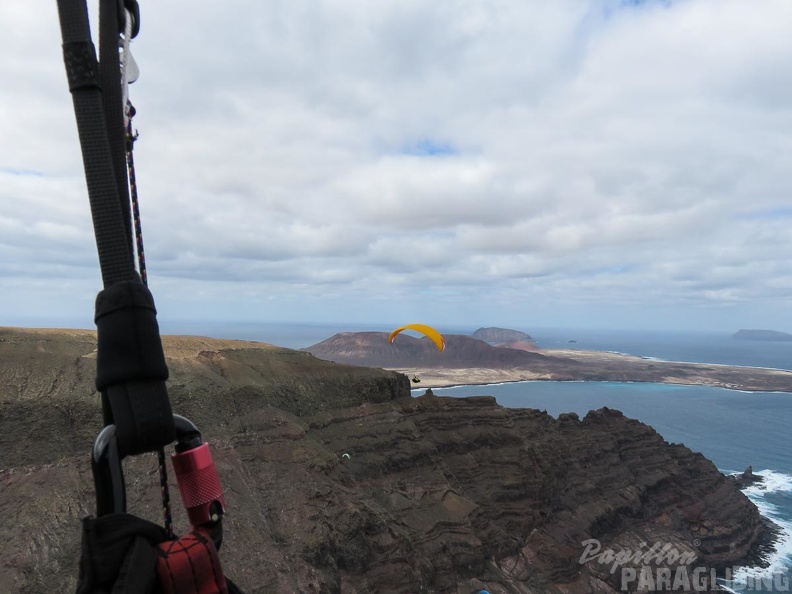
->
{"left": 388, "top": 349, "right": 792, "bottom": 393}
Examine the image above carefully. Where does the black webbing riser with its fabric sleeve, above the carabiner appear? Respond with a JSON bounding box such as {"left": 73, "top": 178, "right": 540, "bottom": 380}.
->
{"left": 58, "top": 0, "right": 176, "bottom": 457}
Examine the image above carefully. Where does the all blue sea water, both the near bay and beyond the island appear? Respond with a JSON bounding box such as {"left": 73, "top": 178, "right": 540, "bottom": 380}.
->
{"left": 162, "top": 323, "right": 792, "bottom": 594}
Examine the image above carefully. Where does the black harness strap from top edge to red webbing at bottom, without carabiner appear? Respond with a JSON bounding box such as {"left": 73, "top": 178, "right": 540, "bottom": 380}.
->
{"left": 58, "top": 0, "right": 240, "bottom": 594}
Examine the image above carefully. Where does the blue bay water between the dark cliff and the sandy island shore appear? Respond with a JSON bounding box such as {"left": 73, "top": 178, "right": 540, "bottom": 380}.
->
{"left": 434, "top": 382, "right": 792, "bottom": 592}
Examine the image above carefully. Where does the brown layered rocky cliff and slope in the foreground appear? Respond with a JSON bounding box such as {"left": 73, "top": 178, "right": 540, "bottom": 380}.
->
{"left": 0, "top": 329, "right": 766, "bottom": 594}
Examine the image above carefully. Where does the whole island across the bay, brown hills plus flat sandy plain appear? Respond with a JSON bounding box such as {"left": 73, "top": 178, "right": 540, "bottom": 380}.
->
{"left": 303, "top": 329, "right": 792, "bottom": 392}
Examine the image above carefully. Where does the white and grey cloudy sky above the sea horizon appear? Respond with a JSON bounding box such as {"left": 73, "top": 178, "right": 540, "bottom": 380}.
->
{"left": 0, "top": 0, "right": 792, "bottom": 332}
